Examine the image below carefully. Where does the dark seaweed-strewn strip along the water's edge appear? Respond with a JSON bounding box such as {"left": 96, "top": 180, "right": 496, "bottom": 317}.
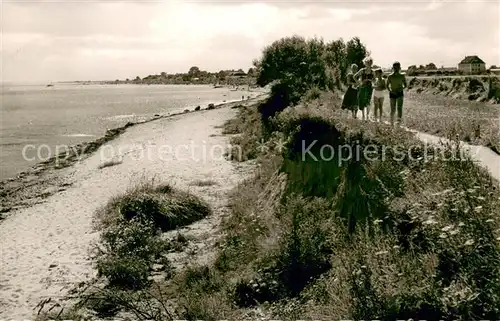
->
{"left": 0, "top": 93, "right": 267, "bottom": 219}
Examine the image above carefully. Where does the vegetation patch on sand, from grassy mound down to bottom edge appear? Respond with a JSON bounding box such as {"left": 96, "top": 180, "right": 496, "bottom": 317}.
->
{"left": 39, "top": 181, "right": 211, "bottom": 320}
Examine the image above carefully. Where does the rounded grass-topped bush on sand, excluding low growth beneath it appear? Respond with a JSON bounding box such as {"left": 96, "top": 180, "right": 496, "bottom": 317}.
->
{"left": 91, "top": 180, "right": 210, "bottom": 309}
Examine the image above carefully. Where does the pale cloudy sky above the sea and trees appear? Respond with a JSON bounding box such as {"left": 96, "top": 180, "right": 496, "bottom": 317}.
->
{"left": 0, "top": 0, "right": 500, "bottom": 82}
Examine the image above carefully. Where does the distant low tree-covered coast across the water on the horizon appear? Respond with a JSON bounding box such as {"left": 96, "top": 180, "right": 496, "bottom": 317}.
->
{"left": 106, "top": 66, "right": 256, "bottom": 86}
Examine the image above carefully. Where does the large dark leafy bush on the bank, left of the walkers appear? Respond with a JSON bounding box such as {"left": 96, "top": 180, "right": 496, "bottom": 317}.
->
{"left": 256, "top": 36, "right": 368, "bottom": 122}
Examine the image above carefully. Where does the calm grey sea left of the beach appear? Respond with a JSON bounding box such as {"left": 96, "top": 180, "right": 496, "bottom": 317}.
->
{"left": 0, "top": 84, "right": 256, "bottom": 180}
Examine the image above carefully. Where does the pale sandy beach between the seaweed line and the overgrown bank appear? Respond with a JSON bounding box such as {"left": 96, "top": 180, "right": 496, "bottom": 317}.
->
{"left": 0, "top": 103, "right": 256, "bottom": 319}
